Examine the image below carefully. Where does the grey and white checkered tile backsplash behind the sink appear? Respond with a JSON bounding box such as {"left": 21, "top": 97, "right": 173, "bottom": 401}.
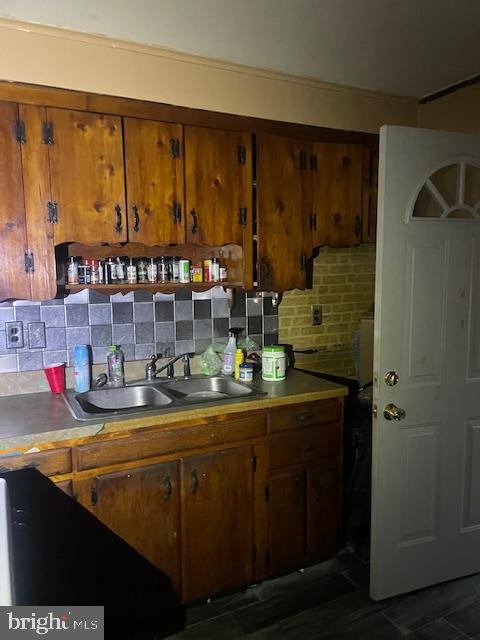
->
{"left": 0, "top": 287, "right": 278, "bottom": 373}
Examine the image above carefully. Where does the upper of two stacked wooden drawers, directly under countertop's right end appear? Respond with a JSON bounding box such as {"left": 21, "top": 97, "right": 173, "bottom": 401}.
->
{"left": 268, "top": 398, "right": 343, "bottom": 433}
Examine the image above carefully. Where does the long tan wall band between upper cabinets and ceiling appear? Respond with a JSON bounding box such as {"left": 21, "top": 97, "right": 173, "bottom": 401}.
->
{"left": 0, "top": 19, "right": 417, "bottom": 132}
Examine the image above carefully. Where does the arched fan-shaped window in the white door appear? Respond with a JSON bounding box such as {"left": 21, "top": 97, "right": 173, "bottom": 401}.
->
{"left": 412, "top": 159, "right": 480, "bottom": 220}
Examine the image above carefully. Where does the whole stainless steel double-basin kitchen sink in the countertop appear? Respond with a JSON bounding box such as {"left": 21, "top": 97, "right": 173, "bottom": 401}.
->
{"left": 63, "top": 376, "right": 264, "bottom": 420}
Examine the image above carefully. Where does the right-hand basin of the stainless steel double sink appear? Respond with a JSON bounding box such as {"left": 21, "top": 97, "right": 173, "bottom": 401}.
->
{"left": 157, "top": 376, "right": 259, "bottom": 403}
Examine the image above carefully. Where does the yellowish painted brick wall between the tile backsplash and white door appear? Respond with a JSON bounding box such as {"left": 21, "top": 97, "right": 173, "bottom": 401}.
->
{"left": 279, "top": 244, "right": 375, "bottom": 376}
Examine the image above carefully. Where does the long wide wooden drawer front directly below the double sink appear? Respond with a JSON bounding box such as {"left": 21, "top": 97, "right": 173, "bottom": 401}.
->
{"left": 77, "top": 415, "right": 265, "bottom": 471}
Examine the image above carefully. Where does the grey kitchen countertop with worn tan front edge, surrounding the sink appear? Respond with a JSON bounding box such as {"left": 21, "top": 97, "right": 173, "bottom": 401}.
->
{"left": 0, "top": 370, "right": 348, "bottom": 460}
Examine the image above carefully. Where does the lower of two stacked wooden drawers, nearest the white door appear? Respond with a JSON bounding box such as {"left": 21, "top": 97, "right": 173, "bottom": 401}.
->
{"left": 268, "top": 424, "right": 342, "bottom": 469}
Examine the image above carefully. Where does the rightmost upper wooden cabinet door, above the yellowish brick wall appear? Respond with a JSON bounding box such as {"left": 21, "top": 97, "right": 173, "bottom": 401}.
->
{"left": 313, "top": 143, "right": 363, "bottom": 247}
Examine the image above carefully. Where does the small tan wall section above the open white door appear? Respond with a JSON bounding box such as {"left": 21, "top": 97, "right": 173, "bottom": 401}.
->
{"left": 418, "top": 84, "right": 480, "bottom": 133}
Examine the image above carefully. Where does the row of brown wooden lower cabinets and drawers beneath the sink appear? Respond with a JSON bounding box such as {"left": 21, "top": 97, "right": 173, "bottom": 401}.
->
{"left": 68, "top": 399, "right": 342, "bottom": 602}
